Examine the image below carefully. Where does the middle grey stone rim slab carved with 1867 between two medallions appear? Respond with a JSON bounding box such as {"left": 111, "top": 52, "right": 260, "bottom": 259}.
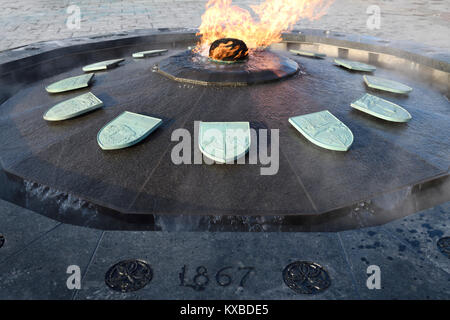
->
{"left": 76, "top": 232, "right": 358, "bottom": 299}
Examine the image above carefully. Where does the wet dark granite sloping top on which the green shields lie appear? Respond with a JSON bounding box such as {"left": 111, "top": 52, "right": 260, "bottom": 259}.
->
{"left": 0, "top": 32, "right": 450, "bottom": 230}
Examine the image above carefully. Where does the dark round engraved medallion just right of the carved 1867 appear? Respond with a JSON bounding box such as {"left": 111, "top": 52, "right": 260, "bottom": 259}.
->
{"left": 283, "top": 261, "right": 331, "bottom": 294}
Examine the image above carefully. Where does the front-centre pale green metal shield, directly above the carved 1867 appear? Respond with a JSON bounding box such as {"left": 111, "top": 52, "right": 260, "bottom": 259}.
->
{"left": 198, "top": 122, "right": 250, "bottom": 163}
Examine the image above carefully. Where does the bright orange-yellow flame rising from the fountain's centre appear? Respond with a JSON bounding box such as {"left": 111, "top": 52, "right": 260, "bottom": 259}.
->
{"left": 195, "top": 0, "right": 334, "bottom": 56}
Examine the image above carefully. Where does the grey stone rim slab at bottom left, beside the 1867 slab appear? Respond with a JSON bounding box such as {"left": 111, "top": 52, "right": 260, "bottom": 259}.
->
{"left": 0, "top": 222, "right": 102, "bottom": 299}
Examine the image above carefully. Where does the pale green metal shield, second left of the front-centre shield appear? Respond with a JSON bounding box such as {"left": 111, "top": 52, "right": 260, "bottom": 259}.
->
{"left": 44, "top": 92, "right": 103, "bottom": 121}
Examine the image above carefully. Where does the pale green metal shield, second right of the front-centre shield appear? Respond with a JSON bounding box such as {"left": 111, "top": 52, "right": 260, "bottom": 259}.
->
{"left": 350, "top": 93, "right": 411, "bottom": 122}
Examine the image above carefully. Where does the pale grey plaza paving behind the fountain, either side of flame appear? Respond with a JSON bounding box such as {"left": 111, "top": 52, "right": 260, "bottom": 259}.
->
{"left": 0, "top": 0, "right": 450, "bottom": 52}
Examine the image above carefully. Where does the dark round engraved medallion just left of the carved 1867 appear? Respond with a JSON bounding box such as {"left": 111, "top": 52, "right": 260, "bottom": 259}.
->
{"left": 105, "top": 260, "right": 153, "bottom": 292}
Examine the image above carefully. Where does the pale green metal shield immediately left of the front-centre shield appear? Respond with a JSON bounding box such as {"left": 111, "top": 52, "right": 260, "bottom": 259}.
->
{"left": 97, "top": 111, "right": 162, "bottom": 150}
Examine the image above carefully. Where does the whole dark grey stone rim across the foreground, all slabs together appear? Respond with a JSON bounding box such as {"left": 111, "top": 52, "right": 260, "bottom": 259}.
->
{"left": 0, "top": 201, "right": 450, "bottom": 300}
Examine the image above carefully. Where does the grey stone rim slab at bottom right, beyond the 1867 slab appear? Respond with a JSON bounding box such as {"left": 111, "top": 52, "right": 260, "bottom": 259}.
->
{"left": 339, "top": 220, "right": 450, "bottom": 299}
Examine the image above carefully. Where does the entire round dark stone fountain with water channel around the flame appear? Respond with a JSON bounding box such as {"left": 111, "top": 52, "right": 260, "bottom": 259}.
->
{"left": 0, "top": 30, "right": 450, "bottom": 231}
